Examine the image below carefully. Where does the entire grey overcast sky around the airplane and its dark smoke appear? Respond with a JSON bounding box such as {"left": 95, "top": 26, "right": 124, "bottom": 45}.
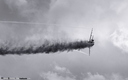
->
{"left": 0, "top": 0, "right": 128, "bottom": 80}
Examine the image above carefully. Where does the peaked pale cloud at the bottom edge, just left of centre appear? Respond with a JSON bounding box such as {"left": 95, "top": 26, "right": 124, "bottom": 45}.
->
{"left": 40, "top": 64, "right": 76, "bottom": 80}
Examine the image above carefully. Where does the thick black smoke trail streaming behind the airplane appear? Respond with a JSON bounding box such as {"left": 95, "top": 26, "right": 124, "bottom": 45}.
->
{"left": 0, "top": 41, "right": 92, "bottom": 55}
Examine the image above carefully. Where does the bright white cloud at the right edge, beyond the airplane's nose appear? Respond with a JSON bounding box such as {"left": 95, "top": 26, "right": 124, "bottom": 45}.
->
{"left": 111, "top": 26, "right": 128, "bottom": 52}
